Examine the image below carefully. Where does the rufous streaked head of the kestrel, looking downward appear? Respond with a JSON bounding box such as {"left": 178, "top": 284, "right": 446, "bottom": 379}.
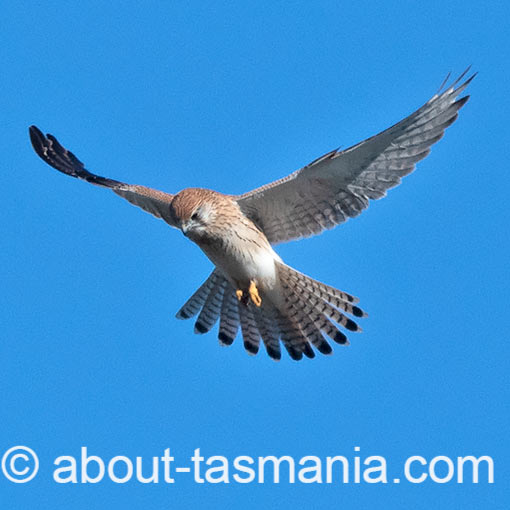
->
{"left": 170, "top": 188, "right": 219, "bottom": 242}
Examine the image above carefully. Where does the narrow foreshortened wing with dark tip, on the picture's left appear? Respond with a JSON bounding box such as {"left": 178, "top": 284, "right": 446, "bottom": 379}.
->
{"left": 29, "top": 126, "right": 178, "bottom": 226}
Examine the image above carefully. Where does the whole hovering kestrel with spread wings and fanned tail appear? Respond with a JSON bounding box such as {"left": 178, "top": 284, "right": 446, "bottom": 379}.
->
{"left": 29, "top": 68, "right": 475, "bottom": 360}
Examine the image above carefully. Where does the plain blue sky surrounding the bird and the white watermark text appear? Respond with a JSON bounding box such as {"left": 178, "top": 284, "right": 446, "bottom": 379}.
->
{"left": 0, "top": 1, "right": 510, "bottom": 509}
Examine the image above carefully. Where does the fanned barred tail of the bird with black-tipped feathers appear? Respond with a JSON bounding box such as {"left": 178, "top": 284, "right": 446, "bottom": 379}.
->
{"left": 177, "top": 262, "right": 366, "bottom": 360}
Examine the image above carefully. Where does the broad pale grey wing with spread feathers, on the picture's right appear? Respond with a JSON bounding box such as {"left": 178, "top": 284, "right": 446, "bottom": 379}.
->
{"left": 237, "top": 68, "right": 475, "bottom": 243}
